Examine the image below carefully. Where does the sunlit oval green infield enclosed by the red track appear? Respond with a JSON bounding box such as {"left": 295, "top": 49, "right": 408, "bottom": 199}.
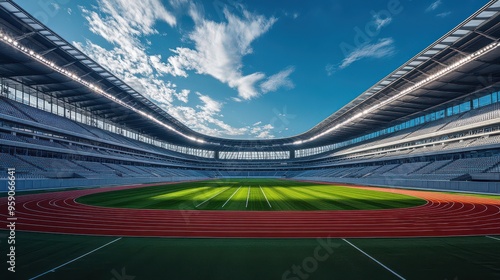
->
{"left": 77, "top": 179, "right": 425, "bottom": 210}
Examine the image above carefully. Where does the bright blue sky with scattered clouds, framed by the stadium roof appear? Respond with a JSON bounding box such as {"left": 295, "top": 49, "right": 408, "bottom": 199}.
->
{"left": 15, "top": 0, "right": 487, "bottom": 139}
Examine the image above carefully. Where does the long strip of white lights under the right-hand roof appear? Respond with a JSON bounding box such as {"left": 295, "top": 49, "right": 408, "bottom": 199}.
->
{"left": 294, "top": 42, "right": 500, "bottom": 144}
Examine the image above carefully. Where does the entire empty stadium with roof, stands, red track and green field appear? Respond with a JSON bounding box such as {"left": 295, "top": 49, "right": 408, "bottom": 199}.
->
{"left": 0, "top": 0, "right": 500, "bottom": 280}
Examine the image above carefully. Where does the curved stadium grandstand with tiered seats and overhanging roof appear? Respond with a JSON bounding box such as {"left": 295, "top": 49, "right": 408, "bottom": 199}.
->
{"left": 0, "top": 2, "right": 500, "bottom": 192}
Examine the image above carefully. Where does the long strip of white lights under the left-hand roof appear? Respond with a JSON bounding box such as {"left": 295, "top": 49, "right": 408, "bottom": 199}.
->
{"left": 0, "top": 32, "right": 206, "bottom": 143}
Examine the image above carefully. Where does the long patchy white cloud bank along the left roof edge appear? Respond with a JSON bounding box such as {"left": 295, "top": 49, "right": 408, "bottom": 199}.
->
{"left": 73, "top": 0, "right": 273, "bottom": 137}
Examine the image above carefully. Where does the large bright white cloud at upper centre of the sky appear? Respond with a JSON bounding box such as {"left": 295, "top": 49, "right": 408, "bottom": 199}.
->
{"left": 168, "top": 5, "right": 276, "bottom": 100}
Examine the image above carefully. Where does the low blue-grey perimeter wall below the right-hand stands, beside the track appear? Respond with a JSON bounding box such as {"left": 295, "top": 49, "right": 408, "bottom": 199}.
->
{"left": 293, "top": 177, "right": 500, "bottom": 194}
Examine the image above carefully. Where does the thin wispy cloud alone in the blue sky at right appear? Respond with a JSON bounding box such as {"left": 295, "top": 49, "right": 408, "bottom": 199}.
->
{"left": 338, "top": 38, "right": 394, "bottom": 71}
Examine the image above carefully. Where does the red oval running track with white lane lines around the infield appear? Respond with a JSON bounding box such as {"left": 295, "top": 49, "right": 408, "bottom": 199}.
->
{"left": 0, "top": 183, "right": 500, "bottom": 238}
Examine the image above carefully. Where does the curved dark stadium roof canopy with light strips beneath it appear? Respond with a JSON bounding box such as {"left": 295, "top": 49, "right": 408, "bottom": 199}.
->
{"left": 0, "top": 1, "right": 500, "bottom": 150}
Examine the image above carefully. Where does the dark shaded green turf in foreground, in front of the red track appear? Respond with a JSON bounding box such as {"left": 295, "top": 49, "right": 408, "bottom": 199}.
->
{"left": 0, "top": 231, "right": 500, "bottom": 280}
